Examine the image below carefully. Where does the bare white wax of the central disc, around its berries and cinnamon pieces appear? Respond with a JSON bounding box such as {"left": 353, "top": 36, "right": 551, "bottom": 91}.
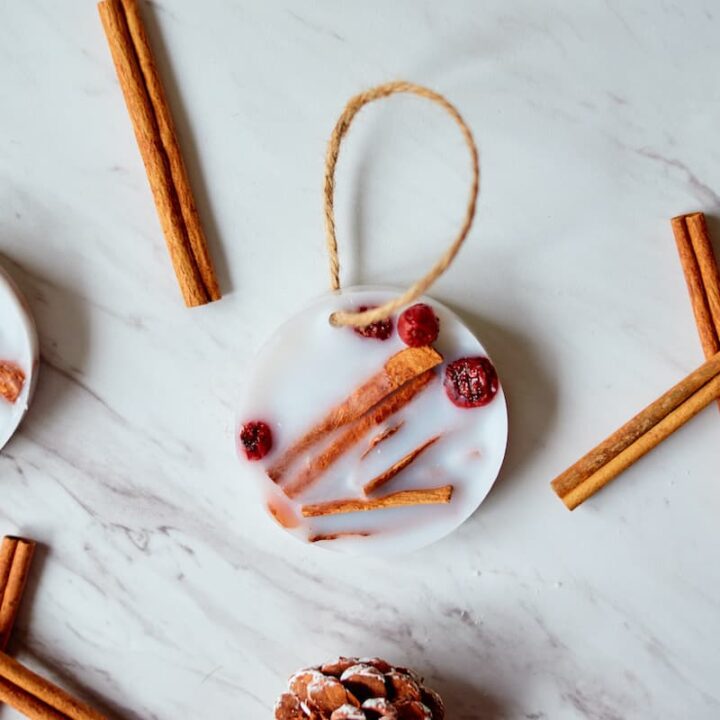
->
{"left": 238, "top": 288, "right": 507, "bottom": 553}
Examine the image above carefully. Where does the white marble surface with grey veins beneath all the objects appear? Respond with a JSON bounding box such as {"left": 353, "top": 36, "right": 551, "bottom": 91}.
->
{"left": 0, "top": 0, "right": 720, "bottom": 720}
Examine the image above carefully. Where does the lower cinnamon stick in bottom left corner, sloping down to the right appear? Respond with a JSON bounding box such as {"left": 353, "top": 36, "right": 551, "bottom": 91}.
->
{"left": 0, "top": 653, "right": 105, "bottom": 720}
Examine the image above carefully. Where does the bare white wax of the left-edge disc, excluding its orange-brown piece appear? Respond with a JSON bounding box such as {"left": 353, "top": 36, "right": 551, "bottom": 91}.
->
{"left": 0, "top": 268, "right": 38, "bottom": 449}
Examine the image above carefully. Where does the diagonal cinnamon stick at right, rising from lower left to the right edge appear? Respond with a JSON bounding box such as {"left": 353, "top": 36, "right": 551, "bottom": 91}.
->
{"left": 551, "top": 353, "right": 720, "bottom": 510}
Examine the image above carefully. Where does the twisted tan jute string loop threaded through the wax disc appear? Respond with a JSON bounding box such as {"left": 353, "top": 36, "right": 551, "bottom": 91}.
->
{"left": 325, "top": 81, "right": 480, "bottom": 327}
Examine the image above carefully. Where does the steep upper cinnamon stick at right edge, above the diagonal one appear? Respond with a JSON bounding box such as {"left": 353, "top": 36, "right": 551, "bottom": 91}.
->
{"left": 671, "top": 213, "right": 720, "bottom": 358}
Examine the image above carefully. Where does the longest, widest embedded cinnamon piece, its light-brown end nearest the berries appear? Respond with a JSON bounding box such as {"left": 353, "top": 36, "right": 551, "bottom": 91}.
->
{"left": 268, "top": 347, "right": 442, "bottom": 482}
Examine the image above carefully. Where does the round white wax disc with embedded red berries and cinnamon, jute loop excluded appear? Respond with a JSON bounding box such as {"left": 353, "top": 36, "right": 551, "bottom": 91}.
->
{"left": 237, "top": 288, "right": 508, "bottom": 553}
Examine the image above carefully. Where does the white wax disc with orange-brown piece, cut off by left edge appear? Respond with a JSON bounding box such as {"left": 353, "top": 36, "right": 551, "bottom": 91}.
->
{"left": 0, "top": 268, "right": 39, "bottom": 450}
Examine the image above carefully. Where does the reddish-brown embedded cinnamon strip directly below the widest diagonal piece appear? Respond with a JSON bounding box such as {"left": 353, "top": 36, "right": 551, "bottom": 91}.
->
{"left": 283, "top": 370, "right": 435, "bottom": 497}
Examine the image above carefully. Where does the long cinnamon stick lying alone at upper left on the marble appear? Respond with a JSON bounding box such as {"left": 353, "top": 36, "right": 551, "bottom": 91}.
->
{"left": 98, "top": 0, "right": 220, "bottom": 307}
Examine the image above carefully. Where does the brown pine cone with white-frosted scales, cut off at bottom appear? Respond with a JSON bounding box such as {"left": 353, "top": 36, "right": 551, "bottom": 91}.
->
{"left": 275, "top": 657, "right": 445, "bottom": 720}
